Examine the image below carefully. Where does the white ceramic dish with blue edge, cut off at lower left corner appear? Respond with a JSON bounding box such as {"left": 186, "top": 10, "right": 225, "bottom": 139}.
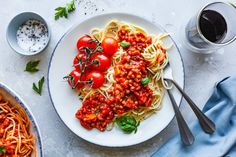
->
{"left": 0, "top": 83, "right": 43, "bottom": 157}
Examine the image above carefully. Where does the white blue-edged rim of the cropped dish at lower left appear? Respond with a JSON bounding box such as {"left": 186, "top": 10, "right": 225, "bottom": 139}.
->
{"left": 0, "top": 82, "right": 43, "bottom": 157}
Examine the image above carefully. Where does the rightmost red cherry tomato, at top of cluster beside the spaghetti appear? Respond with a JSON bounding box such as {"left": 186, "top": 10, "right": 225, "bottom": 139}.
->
{"left": 102, "top": 37, "right": 119, "bottom": 56}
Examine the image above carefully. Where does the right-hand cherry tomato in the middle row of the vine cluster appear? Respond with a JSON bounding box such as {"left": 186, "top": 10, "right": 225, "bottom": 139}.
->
{"left": 92, "top": 53, "right": 111, "bottom": 71}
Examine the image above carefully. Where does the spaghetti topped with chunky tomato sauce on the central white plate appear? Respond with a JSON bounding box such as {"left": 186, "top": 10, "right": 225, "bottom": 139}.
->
{"left": 73, "top": 21, "right": 170, "bottom": 131}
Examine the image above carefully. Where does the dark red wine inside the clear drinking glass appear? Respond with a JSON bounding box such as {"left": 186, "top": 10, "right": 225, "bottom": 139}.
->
{"left": 199, "top": 10, "right": 227, "bottom": 43}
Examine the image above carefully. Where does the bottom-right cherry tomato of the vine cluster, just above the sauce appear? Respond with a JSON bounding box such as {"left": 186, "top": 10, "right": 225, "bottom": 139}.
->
{"left": 86, "top": 70, "right": 105, "bottom": 88}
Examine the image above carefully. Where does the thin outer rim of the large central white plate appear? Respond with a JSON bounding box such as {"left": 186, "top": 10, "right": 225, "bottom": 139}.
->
{"left": 47, "top": 12, "right": 185, "bottom": 148}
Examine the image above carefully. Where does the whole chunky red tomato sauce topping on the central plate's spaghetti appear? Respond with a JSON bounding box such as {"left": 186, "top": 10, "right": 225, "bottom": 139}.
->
{"left": 76, "top": 29, "right": 153, "bottom": 131}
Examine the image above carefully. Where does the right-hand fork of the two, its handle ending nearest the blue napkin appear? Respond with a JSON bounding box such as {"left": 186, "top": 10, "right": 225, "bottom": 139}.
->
{"left": 164, "top": 63, "right": 215, "bottom": 134}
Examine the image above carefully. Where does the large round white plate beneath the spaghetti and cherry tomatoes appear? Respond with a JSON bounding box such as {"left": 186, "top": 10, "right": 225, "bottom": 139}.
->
{"left": 48, "top": 13, "right": 184, "bottom": 147}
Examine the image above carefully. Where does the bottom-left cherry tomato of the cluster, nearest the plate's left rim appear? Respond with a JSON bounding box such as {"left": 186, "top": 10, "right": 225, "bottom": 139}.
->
{"left": 67, "top": 70, "right": 85, "bottom": 89}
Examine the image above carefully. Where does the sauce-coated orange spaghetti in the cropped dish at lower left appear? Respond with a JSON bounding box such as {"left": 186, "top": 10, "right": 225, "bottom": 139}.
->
{"left": 0, "top": 95, "right": 36, "bottom": 157}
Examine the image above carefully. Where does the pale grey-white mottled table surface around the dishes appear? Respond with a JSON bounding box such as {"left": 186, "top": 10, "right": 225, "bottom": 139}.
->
{"left": 0, "top": 0, "right": 236, "bottom": 157}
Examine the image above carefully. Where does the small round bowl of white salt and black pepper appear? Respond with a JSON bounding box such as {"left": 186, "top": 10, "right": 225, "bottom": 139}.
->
{"left": 6, "top": 12, "right": 50, "bottom": 56}
